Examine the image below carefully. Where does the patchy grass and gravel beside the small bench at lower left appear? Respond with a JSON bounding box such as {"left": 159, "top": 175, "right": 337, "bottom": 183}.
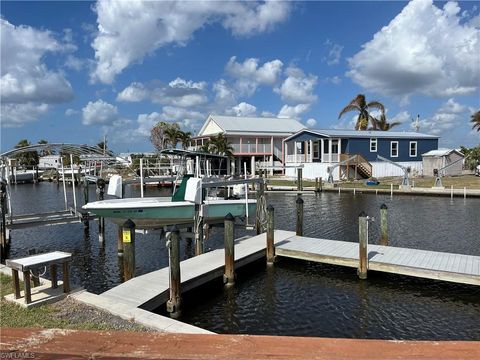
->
{"left": 0, "top": 274, "right": 149, "bottom": 331}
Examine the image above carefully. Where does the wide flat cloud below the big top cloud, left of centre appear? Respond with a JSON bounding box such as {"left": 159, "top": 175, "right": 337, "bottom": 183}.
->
{"left": 117, "top": 78, "right": 208, "bottom": 107}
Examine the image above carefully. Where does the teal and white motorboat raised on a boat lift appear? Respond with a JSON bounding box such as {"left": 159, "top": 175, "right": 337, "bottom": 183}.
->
{"left": 83, "top": 176, "right": 257, "bottom": 229}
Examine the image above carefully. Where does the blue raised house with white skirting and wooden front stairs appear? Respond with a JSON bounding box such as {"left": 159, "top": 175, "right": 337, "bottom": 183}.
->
{"left": 284, "top": 129, "right": 438, "bottom": 180}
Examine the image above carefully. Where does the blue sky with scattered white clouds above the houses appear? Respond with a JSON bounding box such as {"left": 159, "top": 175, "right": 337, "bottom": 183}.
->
{"left": 0, "top": 0, "right": 480, "bottom": 152}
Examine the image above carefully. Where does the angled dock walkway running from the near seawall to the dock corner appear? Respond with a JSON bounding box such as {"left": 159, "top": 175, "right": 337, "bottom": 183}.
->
{"left": 100, "top": 230, "right": 295, "bottom": 310}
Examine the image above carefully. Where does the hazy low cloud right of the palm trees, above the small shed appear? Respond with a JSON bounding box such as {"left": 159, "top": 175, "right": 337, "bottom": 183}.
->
{"left": 410, "top": 98, "right": 470, "bottom": 135}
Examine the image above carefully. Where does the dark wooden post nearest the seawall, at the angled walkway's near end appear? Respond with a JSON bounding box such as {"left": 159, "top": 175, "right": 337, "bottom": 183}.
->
{"left": 167, "top": 225, "right": 182, "bottom": 318}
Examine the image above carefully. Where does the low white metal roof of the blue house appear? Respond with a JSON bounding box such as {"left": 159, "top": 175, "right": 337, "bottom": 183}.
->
{"left": 285, "top": 129, "right": 439, "bottom": 141}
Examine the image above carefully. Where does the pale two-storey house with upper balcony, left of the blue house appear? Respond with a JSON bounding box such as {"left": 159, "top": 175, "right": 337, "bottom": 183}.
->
{"left": 192, "top": 115, "right": 305, "bottom": 174}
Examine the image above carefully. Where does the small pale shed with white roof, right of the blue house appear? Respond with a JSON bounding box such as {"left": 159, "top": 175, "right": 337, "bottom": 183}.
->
{"left": 422, "top": 149, "right": 465, "bottom": 176}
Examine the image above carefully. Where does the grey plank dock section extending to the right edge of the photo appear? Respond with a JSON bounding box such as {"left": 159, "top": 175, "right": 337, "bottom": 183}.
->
{"left": 275, "top": 236, "right": 480, "bottom": 285}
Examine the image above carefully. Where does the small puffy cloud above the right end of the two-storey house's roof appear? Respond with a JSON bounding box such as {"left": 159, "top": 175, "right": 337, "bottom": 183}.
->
{"left": 274, "top": 67, "right": 317, "bottom": 104}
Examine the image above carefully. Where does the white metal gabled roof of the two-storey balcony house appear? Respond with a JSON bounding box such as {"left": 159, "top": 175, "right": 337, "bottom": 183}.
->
{"left": 198, "top": 115, "right": 305, "bottom": 136}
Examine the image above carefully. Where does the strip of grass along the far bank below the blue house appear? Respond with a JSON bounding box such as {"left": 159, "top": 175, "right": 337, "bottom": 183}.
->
{"left": 268, "top": 175, "right": 480, "bottom": 190}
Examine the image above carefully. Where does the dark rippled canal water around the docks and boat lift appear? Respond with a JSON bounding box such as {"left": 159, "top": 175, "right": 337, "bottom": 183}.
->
{"left": 4, "top": 183, "right": 480, "bottom": 340}
